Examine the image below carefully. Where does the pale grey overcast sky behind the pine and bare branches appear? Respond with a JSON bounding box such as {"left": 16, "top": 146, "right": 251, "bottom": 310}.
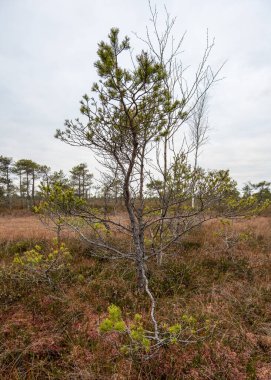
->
{"left": 0, "top": 0, "right": 271, "bottom": 185}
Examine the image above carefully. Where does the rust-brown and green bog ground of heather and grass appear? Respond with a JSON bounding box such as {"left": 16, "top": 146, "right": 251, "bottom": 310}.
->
{"left": 0, "top": 214, "right": 271, "bottom": 380}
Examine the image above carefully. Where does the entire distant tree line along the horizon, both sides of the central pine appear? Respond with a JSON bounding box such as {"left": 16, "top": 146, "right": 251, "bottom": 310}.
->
{"left": 0, "top": 155, "right": 271, "bottom": 214}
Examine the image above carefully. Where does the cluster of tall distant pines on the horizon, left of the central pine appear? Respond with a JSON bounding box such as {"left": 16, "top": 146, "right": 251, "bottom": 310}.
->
{"left": 0, "top": 155, "right": 93, "bottom": 209}
